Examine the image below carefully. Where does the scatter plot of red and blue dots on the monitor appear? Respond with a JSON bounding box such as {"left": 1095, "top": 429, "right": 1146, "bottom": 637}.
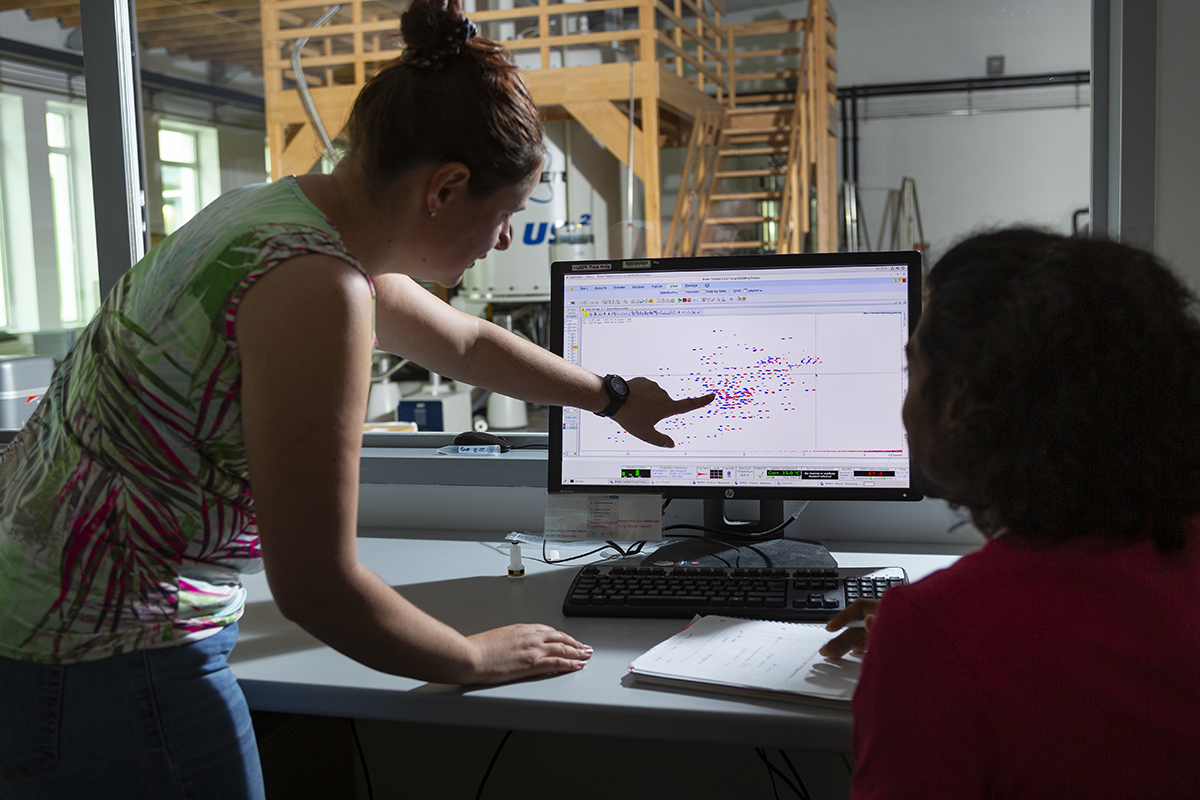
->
{"left": 580, "top": 313, "right": 904, "bottom": 456}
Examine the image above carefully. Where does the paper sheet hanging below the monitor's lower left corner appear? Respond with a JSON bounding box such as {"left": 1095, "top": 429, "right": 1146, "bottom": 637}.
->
{"left": 545, "top": 493, "right": 662, "bottom": 542}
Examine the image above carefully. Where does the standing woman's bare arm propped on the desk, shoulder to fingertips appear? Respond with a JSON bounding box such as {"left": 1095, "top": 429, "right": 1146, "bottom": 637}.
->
{"left": 236, "top": 255, "right": 590, "bottom": 684}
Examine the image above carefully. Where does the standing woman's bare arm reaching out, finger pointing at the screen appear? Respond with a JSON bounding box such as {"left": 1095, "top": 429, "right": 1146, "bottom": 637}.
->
{"left": 376, "top": 275, "right": 713, "bottom": 447}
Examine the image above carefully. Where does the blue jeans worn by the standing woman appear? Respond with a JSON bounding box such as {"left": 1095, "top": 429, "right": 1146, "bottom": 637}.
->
{"left": 0, "top": 625, "right": 264, "bottom": 800}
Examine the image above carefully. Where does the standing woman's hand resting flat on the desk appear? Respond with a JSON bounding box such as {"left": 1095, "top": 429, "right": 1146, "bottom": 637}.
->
{"left": 466, "top": 625, "right": 592, "bottom": 684}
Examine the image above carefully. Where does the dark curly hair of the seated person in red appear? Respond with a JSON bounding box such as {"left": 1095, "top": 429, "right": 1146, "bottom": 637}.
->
{"left": 917, "top": 228, "right": 1200, "bottom": 549}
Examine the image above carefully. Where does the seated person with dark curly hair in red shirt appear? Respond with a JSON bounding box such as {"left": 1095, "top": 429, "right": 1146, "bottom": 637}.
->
{"left": 824, "top": 229, "right": 1200, "bottom": 799}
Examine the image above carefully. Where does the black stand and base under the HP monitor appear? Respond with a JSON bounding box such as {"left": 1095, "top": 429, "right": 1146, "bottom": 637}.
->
{"left": 642, "top": 499, "right": 838, "bottom": 569}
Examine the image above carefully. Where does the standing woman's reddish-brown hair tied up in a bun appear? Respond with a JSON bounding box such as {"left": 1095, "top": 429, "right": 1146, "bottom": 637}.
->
{"left": 347, "top": 0, "right": 545, "bottom": 198}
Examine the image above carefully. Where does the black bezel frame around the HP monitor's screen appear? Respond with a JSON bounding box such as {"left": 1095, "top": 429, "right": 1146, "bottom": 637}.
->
{"left": 546, "top": 251, "right": 924, "bottom": 501}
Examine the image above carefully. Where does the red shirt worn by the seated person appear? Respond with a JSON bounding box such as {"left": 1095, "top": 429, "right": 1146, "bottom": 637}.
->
{"left": 852, "top": 524, "right": 1200, "bottom": 800}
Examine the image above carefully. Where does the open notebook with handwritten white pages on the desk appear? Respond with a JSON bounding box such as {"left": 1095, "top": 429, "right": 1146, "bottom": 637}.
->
{"left": 629, "top": 616, "right": 862, "bottom": 708}
